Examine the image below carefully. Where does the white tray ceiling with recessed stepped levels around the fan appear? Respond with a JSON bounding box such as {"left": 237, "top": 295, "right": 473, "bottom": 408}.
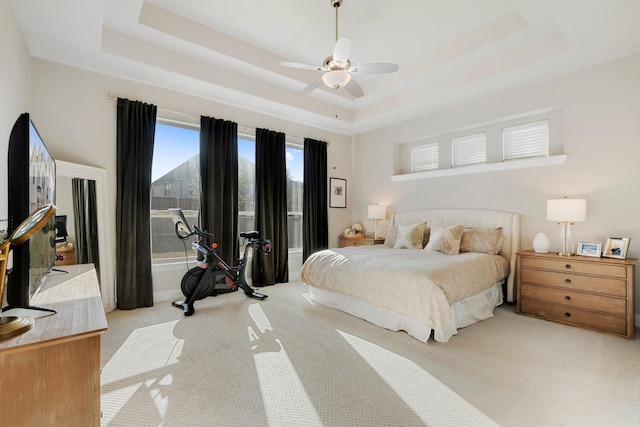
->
{"left": 11, "top": 0, "right": 640, "bottom": 135}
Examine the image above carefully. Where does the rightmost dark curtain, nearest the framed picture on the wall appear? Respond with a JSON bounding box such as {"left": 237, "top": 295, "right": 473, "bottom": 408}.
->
{"left": 302, "top": 138, "right": 329, "bottom": 262}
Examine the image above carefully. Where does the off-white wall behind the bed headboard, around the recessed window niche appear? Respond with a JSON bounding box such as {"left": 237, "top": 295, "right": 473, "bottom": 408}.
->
{"left": 353, "top": 55, "right": 640, "bottom": 323}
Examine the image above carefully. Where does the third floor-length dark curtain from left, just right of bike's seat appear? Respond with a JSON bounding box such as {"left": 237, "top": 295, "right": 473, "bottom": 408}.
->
{"left": 252, "top": 129, "right": 289, "bottom": 286}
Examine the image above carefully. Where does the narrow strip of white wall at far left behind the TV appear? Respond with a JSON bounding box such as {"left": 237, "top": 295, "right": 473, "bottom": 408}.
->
{"left": 0, "top": 0, "right": 31, "bottom": 224}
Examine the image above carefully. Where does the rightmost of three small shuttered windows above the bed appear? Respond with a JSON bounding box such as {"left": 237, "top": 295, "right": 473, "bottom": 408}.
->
{"left": 502, "top": 120, "right": 549, "bottom": 160}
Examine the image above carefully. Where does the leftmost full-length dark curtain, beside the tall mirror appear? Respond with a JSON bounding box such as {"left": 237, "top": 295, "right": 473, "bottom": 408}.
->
{"left": 116, "top": 98, "right": 157, "bottom": 310}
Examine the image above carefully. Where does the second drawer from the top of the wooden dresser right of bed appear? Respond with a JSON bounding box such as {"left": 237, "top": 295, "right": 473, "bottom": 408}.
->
{"left": 521, "top": 270, "right": 627, "bottom": 298}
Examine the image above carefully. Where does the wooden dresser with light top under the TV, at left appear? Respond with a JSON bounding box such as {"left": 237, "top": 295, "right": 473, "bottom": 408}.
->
{"left": 0, "top": 264, "right": 107, "bottom": 427}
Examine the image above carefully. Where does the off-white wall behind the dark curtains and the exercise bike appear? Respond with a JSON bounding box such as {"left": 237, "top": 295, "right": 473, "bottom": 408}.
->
{"left": 31, "top": 58, "right": 352, "bottom": 300}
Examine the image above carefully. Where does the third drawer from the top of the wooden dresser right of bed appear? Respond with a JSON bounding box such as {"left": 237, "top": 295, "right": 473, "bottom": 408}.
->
{"left": 521, "top": 283, "right": 627, "bottom": 316}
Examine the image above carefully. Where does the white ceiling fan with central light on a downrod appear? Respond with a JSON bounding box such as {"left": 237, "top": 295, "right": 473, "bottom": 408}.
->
{"left": 280, "top": 0, "right": 398, "bottom": 98}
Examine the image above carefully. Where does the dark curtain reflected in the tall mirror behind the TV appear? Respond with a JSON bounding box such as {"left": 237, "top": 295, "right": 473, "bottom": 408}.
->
{"left": 71, "top": 178, "right": 100, "bottom": 277}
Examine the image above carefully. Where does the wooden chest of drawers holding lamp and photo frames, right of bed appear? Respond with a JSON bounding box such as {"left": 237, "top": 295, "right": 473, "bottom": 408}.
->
{"left": 516, "top": 251, "right": 637, "bottom": 339}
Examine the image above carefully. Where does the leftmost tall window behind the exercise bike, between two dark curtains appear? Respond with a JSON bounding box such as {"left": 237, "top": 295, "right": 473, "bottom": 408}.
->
{"left": 151, "top": 123, "right": 200, "bottom": 263}
